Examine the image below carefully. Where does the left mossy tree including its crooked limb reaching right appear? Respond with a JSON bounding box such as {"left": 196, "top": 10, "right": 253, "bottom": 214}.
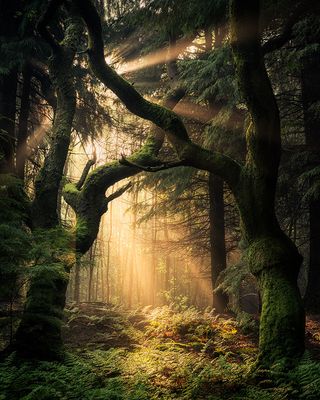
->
{"left": 15, "top": 1, "right": 188, "bottom": 359}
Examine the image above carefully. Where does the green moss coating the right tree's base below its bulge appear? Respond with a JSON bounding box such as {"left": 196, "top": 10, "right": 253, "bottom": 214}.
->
{"left": 258, "top": 268, "right": 305, "bottom": 370}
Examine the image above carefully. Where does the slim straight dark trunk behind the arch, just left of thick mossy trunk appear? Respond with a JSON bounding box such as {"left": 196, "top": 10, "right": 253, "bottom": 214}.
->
{"left": 209, "top": 173, "right": 228, "bottom": 312}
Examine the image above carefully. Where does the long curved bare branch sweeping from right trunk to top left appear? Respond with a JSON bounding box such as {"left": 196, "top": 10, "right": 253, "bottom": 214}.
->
{"left": 73, "top": 0, "right": 241, "bottom": 188}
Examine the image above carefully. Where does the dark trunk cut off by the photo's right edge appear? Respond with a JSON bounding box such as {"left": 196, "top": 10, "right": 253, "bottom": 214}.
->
{"left": 301, "top": 51, "right": 320, "bottom": 314}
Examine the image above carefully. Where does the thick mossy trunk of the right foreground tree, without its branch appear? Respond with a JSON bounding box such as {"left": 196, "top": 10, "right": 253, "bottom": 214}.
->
{"left": 231, "top": 0, "right": 305, "bottom": 367}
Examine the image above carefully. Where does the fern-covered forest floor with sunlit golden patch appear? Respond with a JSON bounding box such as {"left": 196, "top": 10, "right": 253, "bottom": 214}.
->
{"left": 0, "top": 303, "right": 320, "bottom": 400}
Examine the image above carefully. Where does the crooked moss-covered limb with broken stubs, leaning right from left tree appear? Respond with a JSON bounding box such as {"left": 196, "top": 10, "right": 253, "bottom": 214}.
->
{"left": 63, "top": 50, "right": 189, "bottom": 254}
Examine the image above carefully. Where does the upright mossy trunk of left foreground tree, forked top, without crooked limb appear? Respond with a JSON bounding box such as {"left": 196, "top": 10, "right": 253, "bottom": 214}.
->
{"left": 15, "top": 7, "right": 81, "bottom": 359}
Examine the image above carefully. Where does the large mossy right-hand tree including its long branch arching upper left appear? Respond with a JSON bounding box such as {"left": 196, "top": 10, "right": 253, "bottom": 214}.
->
{"left": 65, "top": 0, "right": 304, "bottom": 366}
